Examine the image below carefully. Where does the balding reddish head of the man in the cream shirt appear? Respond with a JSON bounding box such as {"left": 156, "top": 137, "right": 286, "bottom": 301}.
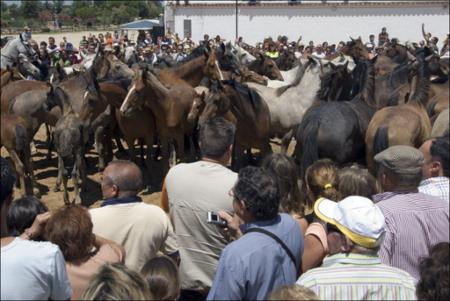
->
{"left": 102, "top": 160, "right": 143, "bottom": 197}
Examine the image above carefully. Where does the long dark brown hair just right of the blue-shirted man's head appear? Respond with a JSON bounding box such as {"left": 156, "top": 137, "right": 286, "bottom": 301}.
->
{"left": 261, "top": 153, "right": 305, "bottom": 215}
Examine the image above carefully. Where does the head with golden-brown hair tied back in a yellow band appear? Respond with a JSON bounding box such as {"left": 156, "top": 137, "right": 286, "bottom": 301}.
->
{"left": 305, "top": 159, "right": 339, "bottom": 202}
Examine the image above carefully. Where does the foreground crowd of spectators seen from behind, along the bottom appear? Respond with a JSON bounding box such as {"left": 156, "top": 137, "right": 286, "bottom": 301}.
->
{"left": 0, "top": 117, "right": 450, "bottom": 300}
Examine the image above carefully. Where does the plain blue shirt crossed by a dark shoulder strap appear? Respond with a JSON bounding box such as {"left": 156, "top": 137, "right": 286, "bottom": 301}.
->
{"left": 208, "top": 213, "right": 303, "bottom": 300}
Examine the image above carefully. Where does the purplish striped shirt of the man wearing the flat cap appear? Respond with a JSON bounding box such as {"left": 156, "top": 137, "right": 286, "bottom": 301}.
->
{"left": 373, "top": 190, "right": 449, "bottom": 279}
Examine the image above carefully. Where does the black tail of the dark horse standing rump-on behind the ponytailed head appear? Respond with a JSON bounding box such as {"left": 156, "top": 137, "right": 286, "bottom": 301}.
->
{"left": 297, "top": 119, "right": 320, "bottom": 178}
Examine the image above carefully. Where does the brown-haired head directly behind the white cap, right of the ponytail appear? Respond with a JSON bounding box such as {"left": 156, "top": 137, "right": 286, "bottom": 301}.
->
{"left": 338, "top": 165, "right": 380, "bottom": 199}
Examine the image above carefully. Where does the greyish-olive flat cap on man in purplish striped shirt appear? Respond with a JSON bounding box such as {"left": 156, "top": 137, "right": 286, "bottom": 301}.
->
{"left": 374, "top": 145, "right": 424, "bottom": 174}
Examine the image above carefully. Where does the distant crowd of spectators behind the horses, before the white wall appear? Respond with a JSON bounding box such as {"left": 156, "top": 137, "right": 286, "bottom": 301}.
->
{"left": 14, "top": 27, "right": 450, "bottom": 77}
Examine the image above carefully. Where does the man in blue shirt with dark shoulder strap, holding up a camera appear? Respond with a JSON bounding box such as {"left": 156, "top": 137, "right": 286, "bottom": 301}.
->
{"left": 208, "top": 166, "right": 303, "bottom": 300}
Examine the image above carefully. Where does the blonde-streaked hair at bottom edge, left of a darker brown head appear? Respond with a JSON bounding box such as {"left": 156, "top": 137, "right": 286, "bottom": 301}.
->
{"left": 81, "top": 263, "right": 153, "bottom": 300}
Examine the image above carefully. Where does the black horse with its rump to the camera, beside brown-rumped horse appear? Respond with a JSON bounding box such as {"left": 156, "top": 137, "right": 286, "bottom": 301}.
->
{"left": 295, "top": 61, "right": 376, "bottom": 178}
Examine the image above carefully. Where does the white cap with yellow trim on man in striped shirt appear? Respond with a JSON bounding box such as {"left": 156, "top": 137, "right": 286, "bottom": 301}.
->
{"left": 314, "top": 196, "right": 386, "bottom": 249}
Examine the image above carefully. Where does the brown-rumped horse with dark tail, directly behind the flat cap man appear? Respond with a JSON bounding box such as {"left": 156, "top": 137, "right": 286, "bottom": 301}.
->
{"left": 366, "top": 47, "right": 431, "bottom": 174}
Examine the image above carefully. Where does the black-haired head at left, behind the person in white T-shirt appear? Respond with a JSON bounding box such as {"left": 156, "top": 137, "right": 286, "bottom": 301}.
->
{"left": 6, "top": 196, "right": 48, "bottom": 236}
